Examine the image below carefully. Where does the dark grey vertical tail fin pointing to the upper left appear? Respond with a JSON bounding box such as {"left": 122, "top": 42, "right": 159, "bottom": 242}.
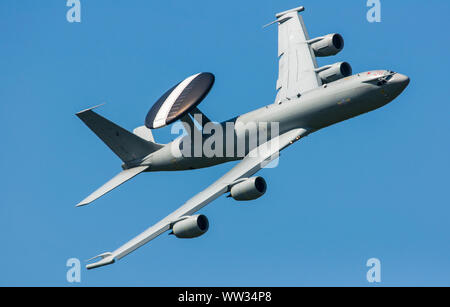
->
{"left": 76, "top": 108, "right": 163, "bottom": 163}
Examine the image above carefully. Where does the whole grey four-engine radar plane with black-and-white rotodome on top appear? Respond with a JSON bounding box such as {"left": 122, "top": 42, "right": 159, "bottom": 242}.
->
{"left": 77, "top": 7, "right": 409, "bottom": 269}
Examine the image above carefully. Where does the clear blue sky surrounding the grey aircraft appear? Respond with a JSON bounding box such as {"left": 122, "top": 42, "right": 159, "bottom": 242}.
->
{"left": 0, "top": 0, "right": 450, "bottom": 286}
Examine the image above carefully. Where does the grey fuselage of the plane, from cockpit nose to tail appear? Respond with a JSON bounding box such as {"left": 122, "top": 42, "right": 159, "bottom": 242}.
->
{"left": 139, "top": 70, "right": 409, "bottom": 171}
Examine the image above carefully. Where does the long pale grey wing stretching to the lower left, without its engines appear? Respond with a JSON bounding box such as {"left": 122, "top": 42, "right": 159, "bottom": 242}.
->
{"left": 86, "top": 128, "right": 308, "bottom": 269}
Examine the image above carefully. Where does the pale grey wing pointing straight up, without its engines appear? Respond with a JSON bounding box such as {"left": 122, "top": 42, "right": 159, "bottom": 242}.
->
{"left": 269, "top": 7, "right": 322, "bottom": 103}
